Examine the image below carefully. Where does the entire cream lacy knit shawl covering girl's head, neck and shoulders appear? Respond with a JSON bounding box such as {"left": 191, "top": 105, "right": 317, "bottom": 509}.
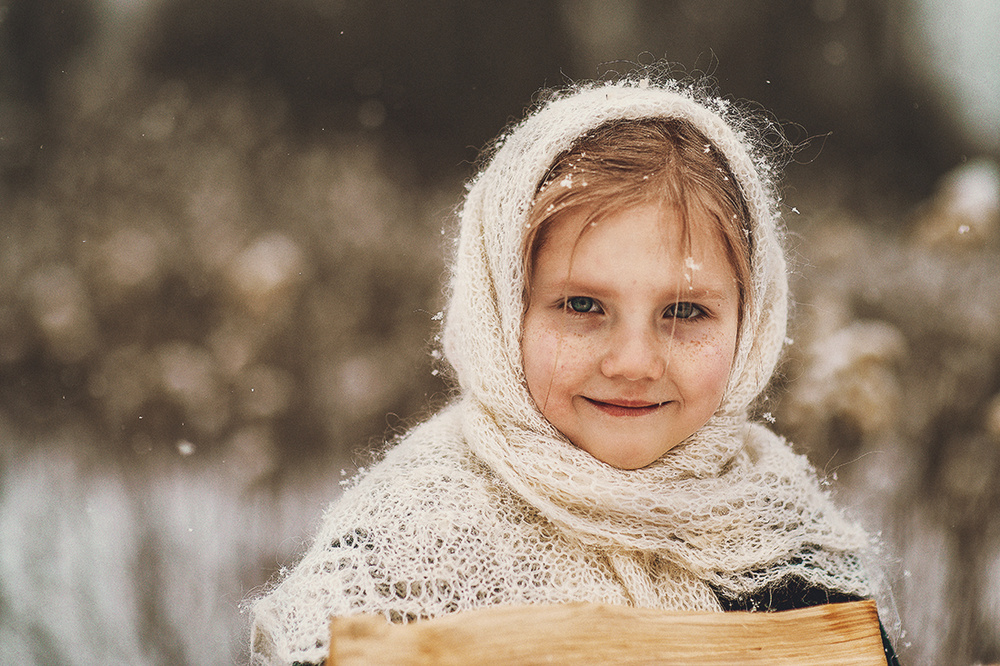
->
{"left": 251, "top": 79, "right": 871, "bottom": 664}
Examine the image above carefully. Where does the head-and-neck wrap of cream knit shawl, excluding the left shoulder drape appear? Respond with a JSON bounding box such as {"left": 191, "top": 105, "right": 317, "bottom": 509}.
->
{"left": 444, "top": 80, "right": 864, "bottom": 595}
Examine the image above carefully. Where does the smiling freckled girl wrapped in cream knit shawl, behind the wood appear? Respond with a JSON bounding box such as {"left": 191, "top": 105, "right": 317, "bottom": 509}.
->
{"left": 252, "top": 78, "right": 892, "bottom": 664}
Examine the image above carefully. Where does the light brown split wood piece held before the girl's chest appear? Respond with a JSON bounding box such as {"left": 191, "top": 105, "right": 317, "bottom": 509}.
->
{"left": 327, "top": 601, "right": 885, "bottom": 666}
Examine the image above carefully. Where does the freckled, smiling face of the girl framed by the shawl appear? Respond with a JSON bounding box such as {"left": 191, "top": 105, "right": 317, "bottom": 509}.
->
{"left": 521, "top": 205, "right": 739, "bottom": 469}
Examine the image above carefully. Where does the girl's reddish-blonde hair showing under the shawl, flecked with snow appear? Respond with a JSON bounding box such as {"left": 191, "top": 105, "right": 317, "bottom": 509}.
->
{"left": 523, "top": 118, "right": 752, "bottom": 321}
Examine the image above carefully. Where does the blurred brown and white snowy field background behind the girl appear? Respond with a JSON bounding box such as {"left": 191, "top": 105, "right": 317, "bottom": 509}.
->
{"left": 0, "top": 0, "right": 1000, "bottom": 665}
